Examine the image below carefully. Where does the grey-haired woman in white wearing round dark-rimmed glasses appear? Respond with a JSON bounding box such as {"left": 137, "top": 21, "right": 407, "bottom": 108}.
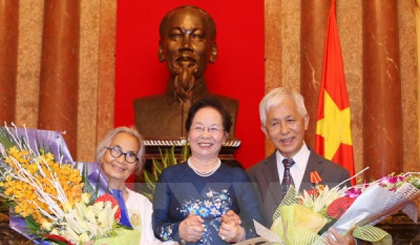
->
{"left": 95, "top": 127, "right": 176, "bottom": 245}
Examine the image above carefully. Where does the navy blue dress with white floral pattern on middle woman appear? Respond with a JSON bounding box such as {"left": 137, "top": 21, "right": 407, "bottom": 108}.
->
{"left": 153, "top": 163, "right": 262, "bottom": 245}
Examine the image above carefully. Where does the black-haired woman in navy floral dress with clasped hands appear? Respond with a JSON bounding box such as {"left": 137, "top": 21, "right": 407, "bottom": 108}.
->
{"left": 153, "top": 97, "right": 262, "bottom": 245}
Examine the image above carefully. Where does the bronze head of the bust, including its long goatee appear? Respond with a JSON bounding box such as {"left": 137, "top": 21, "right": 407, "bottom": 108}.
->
{"left": 158, "top": 6, "right": 217, "bottom": 100}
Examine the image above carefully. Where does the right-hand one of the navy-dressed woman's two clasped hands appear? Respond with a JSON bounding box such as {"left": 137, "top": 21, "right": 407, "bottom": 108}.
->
{"left": 219, "top": 210, "right": 246, "bottom": 243}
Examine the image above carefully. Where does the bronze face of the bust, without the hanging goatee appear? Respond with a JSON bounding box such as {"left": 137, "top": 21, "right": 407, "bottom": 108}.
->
{"left": 159, "top": 8, "right": 217, "bottom": 80}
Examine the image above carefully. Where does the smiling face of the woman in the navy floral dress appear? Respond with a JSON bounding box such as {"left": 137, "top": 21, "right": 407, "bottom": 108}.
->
{"left": 188, "top": 107, "right": 227, "bottom": 161}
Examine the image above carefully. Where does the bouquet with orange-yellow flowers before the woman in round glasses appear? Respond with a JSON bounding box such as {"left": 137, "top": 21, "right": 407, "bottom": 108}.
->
{"left": 0, "top": 127, "right": 140, "bottom": 245}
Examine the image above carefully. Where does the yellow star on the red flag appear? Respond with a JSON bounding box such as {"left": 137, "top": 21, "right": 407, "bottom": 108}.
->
{"left": 316, "top": 91, "right": 353, "bottom": 160}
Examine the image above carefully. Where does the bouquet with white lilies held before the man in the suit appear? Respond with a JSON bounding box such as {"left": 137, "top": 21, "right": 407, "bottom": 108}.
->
{"left": 256, "top": 173, "right": 420, "bottom": 245}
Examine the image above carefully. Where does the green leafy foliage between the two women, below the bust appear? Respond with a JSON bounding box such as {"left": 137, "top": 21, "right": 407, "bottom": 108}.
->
{"left": 141, "top": 143, "right": 190, "bottom": 201}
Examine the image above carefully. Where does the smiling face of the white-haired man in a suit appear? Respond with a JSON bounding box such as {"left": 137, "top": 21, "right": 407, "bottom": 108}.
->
{"left": 262, "top": 98, "right": 309, "bottom": 157}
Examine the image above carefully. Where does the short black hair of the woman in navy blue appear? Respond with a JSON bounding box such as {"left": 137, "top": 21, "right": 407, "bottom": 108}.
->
{"left": 185, "top": 96, "right": 232, "bottom": 134}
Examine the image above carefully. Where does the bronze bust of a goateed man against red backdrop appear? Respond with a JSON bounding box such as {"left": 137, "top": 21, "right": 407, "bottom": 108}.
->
{"left": 133, "top": 6, "right": 239, "bottom": 138}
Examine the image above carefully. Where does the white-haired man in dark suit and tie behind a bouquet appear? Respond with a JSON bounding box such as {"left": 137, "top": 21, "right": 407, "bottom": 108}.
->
{"left": 247, "top": 87, "right": 354, "bottom": 244}
